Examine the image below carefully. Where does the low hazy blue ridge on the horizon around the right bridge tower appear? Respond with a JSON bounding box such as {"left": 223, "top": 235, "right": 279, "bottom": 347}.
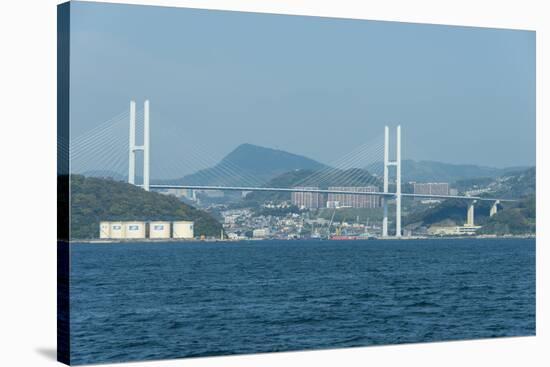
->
{"left": 368, "top": 159, "right": 527, "bottom": 183}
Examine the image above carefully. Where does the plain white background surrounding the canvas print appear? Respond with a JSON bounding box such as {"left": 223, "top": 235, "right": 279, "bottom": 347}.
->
{"left": 0, "top": 0, "right": 550, "bottom": 367}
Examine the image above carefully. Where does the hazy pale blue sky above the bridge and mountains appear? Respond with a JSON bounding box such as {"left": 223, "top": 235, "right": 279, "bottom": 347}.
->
{"left": 71, "top": 3, "right": 535, "bottom": 177}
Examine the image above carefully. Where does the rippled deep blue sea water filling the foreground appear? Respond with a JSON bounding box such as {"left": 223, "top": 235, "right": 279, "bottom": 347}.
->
{"left": 71, "top": 239, "right": 536, "bottom": 364}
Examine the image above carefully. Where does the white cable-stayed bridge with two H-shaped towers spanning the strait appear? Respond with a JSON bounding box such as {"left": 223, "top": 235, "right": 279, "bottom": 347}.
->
{"left": 68, "top": 101, "right": 515, "bottom": 237}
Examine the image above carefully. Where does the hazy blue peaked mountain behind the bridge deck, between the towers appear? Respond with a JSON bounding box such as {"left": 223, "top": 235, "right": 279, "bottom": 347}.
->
{"left": 164, "top": 144, "right": 325, "bottom": 186}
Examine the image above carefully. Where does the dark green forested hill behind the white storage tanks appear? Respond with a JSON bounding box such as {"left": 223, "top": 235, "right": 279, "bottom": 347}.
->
{"left": 71, "top": 175, "right": 222, "bottom": 239}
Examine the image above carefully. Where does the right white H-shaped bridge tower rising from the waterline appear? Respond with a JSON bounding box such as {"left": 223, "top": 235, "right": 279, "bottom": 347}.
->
{"left": 382, "top": 125, "right": 401, "bottom": 237}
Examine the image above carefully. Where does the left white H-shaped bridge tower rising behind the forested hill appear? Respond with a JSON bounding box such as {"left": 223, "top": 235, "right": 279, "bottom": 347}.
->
{"left": 128, "top": 100, "right": 150, "bottom": 191}
